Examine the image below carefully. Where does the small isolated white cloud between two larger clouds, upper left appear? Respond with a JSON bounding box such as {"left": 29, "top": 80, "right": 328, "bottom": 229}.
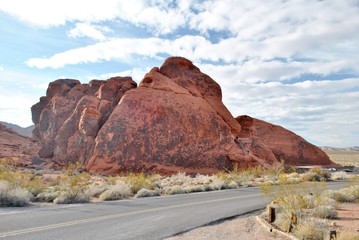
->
{"left": 67, "top": 23, "right": 112, "bottom": 41}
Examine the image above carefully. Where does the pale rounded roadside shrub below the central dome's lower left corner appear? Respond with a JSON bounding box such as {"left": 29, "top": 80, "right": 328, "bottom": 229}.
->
{"left": 100, "top": 181, "right": 133, "bottom": 201}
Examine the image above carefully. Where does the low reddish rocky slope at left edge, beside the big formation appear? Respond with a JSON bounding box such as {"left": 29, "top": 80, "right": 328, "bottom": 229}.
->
{"left": 0, "top": 124, "right": 40, "bottom": 166}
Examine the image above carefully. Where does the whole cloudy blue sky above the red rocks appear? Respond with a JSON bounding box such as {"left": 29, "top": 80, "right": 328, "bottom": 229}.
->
{"left": 0, "top": 0, "right": 359, "bottom": 147}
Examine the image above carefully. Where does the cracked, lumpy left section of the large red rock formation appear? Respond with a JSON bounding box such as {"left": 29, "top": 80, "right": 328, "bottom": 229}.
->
{"left": 31, "top": 77, "right": 137, "bottom": 166}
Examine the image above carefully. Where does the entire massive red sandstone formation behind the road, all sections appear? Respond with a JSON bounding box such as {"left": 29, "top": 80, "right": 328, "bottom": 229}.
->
{"left": 32, "top": 57, "right": 338, "bottom": 174}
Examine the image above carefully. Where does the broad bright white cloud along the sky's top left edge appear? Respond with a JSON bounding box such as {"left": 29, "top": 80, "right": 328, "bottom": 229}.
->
{"left": 0, "top": 0, "right": 190, "bottom": 34}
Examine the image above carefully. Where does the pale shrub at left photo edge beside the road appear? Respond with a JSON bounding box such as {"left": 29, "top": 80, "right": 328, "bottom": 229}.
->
{"left": 0, "top": 181, "right": 31, "bottom": 207}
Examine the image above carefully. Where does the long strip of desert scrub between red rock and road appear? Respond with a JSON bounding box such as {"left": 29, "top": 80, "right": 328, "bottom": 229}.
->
{"left": 0, "top": 159, "right": 358, "bottom": 208}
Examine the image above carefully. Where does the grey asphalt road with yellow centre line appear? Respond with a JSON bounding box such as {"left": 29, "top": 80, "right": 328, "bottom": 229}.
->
{"left": 0, "top": 182, "right": 345, "bottom": 240}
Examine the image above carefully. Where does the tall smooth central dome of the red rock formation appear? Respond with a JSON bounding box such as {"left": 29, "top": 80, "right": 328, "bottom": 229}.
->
{"left": 87, "top": 58, "right": 255, "bottom": 173}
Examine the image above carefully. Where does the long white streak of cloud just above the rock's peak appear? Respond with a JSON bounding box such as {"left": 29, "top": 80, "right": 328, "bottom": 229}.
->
{"left": 27, "top": 36, "right": 211, "bottom": 68}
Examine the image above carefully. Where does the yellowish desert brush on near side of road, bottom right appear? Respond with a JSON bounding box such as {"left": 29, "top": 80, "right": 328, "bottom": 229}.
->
{"left": 261, "top": 182, "right": 359, "bottom": 240}
